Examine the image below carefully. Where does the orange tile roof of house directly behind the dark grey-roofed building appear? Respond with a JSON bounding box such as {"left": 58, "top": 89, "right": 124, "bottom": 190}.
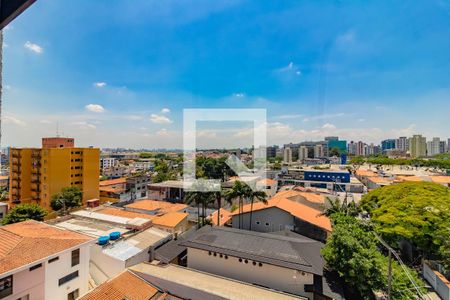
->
{"left": 231, "top": 190, "right": 332, "bottom": 232}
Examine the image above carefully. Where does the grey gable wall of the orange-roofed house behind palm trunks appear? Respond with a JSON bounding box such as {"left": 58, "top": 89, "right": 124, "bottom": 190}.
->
{"left": 232, "top": 207, "right": 294, "bottom": 232}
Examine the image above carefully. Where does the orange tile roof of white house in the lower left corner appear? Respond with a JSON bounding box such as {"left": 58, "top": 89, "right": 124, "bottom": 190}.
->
{"left": 0, "top": 220, "right": 93, "bottom": 274}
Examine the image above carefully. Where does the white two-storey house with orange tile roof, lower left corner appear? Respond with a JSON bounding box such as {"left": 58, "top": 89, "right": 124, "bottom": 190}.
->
{"left": 0, "top": 220, "right": 95, "bottom": 300}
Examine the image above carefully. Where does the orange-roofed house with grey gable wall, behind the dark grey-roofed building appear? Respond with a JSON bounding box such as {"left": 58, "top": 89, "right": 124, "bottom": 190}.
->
{"left": 231, "top": 190, "right": 332, "bottom": 241}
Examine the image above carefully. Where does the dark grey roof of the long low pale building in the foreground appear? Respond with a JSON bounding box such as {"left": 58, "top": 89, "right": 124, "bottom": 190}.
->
{"left": 180, "top": 226, "right": 324, "bottom": 276}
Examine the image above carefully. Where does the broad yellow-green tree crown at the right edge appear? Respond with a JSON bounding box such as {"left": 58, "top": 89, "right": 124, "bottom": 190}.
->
{"left": 361, "top": 182, "right": 450, "bottom": 266}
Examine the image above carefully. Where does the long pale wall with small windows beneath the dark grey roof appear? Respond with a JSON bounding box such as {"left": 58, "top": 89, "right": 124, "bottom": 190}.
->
{"left": 188, "top": 248, "right": 314, "bottom": 299}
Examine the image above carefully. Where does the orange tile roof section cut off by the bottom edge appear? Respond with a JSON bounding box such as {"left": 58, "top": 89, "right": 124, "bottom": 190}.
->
{"left": 80, "top": 271, "right": 159, "bottom": 300}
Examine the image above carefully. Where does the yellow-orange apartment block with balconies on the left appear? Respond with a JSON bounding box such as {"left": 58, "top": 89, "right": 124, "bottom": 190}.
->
{"left": 9, "top": 147, "right": 100, "bottom": 210}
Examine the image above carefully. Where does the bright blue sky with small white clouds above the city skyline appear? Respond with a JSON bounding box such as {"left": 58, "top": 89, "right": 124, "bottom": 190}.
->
{"left": 2, "top": 0, "right": 450, "bottom": 148}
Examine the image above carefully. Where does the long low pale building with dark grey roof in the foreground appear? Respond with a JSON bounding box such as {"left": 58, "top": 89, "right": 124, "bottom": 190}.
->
{"left": 181, "top": 226, "right": 342, "bottom": 299}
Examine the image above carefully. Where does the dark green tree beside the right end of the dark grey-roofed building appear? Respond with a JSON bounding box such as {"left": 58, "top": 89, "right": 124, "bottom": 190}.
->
{"left": 322, "top": 214, "right": 423, "bottom": 300}
